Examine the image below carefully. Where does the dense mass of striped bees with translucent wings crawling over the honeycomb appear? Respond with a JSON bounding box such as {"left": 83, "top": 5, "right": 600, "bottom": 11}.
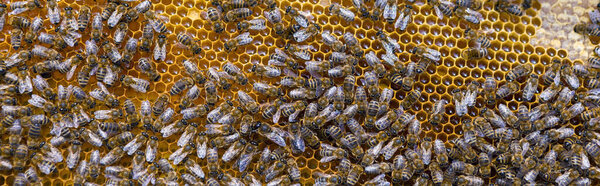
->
{"left": 0, "top": 0, "right": 600, "bottom": 186}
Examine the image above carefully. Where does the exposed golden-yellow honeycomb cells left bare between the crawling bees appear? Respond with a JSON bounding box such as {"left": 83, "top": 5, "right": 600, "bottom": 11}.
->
{"left": 0, "top": 0, "right": 589, "bottom": 185}
